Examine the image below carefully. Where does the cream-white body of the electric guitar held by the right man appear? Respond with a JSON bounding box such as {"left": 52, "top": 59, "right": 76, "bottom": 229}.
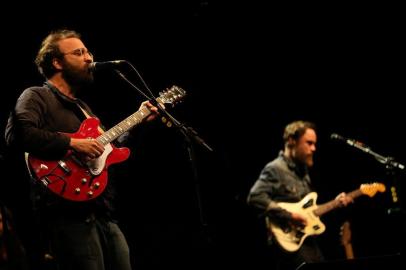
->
{"left": 267, "top": 192, "right": 326, "bottom": 252}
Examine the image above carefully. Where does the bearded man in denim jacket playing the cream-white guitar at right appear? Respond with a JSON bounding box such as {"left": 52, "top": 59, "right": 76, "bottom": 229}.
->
{"left": 247, "top": 121, "right": 352, "bottom": 269}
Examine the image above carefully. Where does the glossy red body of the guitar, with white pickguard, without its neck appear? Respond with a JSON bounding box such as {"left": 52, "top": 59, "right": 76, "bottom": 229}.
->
{"left": 27, "top": 118, "right": 130, "bottom": 201}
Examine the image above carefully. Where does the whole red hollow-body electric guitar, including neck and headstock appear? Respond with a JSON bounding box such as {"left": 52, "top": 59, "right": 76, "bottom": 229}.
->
{"left": 26, "top": 86, "right": 185, "bottom": 201}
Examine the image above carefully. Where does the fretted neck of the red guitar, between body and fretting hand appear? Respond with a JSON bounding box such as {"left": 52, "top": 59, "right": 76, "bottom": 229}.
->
{"left": 96, "top": 107, "right": 151, "bottom": 145}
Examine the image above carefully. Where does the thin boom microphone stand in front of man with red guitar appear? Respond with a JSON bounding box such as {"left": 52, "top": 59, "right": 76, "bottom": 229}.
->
{"left": 114, "top": 67, "right": 213, "bottom": 243}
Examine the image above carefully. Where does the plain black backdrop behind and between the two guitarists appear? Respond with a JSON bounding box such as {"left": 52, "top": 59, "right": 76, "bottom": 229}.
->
{"left": 0, "top": 0, "right": 406, "bottom": 269}
